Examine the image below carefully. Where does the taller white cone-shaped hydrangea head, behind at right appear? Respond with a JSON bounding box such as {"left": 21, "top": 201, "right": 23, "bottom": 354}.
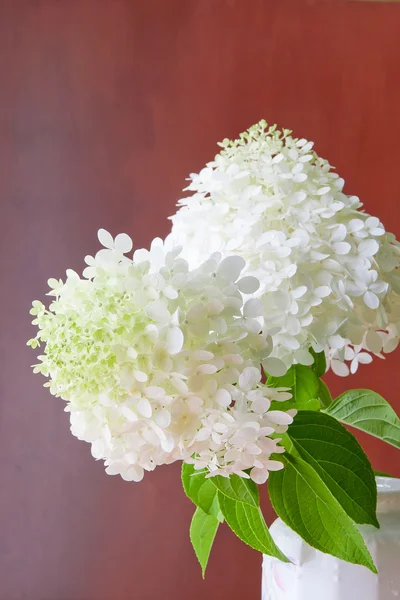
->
{"left": 166, "top": 121, "right": 400, "bottom": 376}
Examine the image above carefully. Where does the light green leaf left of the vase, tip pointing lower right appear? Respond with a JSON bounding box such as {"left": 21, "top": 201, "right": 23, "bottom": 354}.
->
{"left": 218, "top": 492, "right": 289, "bottom": 562}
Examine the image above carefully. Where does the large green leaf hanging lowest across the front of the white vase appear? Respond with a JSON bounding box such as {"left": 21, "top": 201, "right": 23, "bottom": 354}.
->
{"left": 268, "top": 454, "right": 377, "bottom": 573}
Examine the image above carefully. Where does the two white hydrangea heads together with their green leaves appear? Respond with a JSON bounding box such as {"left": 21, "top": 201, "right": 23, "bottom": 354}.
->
{"left": 28, "top": 121, "right": 400, "bottom": 574}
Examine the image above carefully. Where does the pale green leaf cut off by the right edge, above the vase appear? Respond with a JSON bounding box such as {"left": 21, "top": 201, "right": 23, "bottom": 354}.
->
{"left": 325, "top": 390, "right": 400, "bottom": 448}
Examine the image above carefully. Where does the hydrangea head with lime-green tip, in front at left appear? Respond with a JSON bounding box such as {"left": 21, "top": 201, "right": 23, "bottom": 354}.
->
{"left": 29, "top": 230, "right": 295, "bottom": 483}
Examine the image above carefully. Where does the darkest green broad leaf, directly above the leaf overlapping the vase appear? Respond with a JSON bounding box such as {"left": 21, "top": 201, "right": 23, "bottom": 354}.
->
{"left": 286, "top": 411, "right": 379, "bottom": 528}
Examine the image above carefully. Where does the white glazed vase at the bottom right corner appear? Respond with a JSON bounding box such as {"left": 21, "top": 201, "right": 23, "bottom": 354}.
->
{"left": 262, "top": 477, "right": 400, "bottom": 600}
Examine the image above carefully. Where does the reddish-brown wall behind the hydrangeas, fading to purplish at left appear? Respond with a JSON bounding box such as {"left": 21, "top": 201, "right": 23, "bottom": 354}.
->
{"left": 0, "top": 0, "right": 400, "bottom": 600}
